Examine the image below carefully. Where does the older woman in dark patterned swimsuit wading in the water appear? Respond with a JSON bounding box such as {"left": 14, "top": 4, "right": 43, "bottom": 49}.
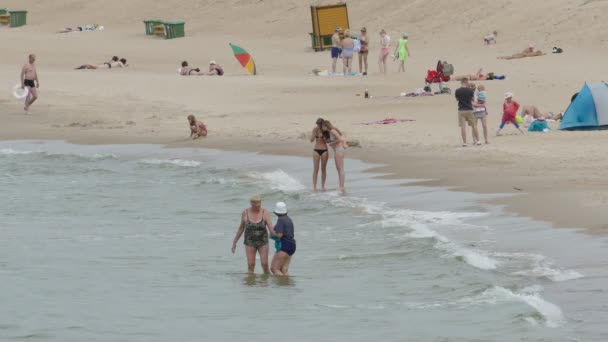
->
{"left": 232, "top": 196, "right": 276, "bottom": 274}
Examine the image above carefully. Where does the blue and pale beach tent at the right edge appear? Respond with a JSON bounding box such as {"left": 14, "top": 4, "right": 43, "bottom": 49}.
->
{"left": 559, "top": 83, "right": 608, "bottom": 130}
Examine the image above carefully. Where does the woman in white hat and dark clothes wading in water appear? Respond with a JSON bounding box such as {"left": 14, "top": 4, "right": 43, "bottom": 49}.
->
{"left": 270, "top": 202, "right": 296, "bottom": 276}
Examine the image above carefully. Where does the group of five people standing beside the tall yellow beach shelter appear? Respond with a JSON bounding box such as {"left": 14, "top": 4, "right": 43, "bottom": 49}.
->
{"left": 331, "top": 27, "right": 411, "bottom": 76}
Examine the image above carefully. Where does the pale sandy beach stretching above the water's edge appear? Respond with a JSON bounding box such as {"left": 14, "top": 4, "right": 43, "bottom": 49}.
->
{"left": 0, "top": 0, "right": 608, "bottom": 233}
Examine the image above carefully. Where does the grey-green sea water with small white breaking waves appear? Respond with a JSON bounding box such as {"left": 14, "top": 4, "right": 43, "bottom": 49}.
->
{"left": 0, "top": 142, "right": 608, "bottom": 342}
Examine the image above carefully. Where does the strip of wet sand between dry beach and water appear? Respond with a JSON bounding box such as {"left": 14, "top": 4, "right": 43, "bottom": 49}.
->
{"left": 0, "top": 127, "right": 608, "bottom": 235}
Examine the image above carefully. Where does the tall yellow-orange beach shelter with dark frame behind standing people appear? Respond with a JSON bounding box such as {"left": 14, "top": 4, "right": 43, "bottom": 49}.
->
{"left": 310, "top": 3, "right": 350, "bottom": 51}
